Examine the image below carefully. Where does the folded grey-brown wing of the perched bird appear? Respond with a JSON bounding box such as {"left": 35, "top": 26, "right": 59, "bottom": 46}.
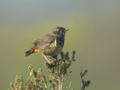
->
{"left": 33, "top": 34, "right": 55, "bottom": 46}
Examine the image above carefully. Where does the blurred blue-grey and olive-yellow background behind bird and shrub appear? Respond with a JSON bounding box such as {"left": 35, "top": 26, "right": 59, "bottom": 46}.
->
{"left": 0, "top": 0, "right": 120, "bottom": 90}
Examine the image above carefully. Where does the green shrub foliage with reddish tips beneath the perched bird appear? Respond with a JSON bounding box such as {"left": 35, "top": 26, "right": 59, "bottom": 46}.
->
{"left": 8, "top": 51, "right": 90, "bottom": 90}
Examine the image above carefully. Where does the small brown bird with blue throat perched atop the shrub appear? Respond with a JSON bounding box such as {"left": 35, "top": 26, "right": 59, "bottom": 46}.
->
{"left": 25, "top": 27, "right": 68, "bottom": 64}
